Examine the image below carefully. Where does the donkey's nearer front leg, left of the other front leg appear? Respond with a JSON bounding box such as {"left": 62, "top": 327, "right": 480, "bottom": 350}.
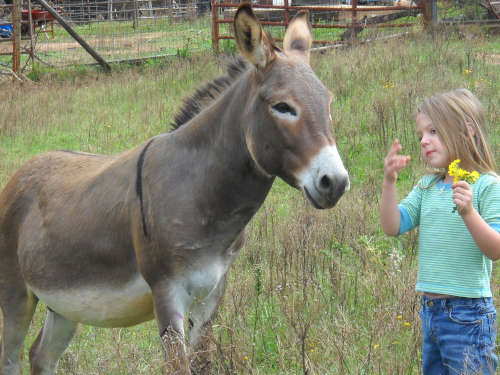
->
{"left": 152, "top": 281, "right": 190, "bottom": 375}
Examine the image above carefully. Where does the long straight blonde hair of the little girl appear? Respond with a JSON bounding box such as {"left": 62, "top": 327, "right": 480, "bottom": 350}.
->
{"left": 418, "top": 89, "right": 497, "bottom": 176}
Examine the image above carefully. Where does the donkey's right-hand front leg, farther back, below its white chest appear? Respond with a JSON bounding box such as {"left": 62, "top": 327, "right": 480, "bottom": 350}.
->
{"left": 188, "top": 273, "right": 227, "bottom": 375}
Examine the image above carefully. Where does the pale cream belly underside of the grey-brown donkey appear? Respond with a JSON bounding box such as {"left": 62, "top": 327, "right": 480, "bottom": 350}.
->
{"left": 31, "top": 276, "right": 154, "bottom": 327}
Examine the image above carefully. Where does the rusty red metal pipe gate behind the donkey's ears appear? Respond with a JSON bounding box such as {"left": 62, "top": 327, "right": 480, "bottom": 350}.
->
{"left": 212, "top": 0, "right": 426, "bottom": 51}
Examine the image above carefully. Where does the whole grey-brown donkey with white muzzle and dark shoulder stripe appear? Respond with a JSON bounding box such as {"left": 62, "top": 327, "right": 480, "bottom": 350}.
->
{"left": 0, "top": 3, "right": 350, "bottom": 375}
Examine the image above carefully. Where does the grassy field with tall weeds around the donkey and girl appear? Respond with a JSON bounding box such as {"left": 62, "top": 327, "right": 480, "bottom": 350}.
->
{"left": 0, "top": 24, "right": 500, "bottom": 374}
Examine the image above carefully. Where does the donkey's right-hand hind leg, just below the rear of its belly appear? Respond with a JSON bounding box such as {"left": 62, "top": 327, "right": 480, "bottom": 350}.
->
{"left": 30, "top": 310, "right": 78, "bottom": 375}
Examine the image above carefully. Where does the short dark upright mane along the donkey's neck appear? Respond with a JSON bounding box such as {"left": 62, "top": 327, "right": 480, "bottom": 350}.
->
{"left": 171, "top": 57, "right": 250, "bottom": 130}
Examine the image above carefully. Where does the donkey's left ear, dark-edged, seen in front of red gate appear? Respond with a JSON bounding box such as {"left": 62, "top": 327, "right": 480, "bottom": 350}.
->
{"left": 234, "top": 3, "right": 275, "bottom": 68}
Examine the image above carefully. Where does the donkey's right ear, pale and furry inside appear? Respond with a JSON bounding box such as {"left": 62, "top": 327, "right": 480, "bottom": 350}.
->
{"left": 283, "top": 10, "right": 313, "bottom": 60}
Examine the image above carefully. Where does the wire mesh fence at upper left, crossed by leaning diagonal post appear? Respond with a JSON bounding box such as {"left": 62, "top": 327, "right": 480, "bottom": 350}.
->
{"left": 0, "top": 0, "right": 212, "bottom": 67}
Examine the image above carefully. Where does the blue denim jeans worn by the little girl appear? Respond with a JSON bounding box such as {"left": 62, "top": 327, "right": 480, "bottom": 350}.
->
{"left": 420, "top": 296, "right": 498, "bottom": 375}
